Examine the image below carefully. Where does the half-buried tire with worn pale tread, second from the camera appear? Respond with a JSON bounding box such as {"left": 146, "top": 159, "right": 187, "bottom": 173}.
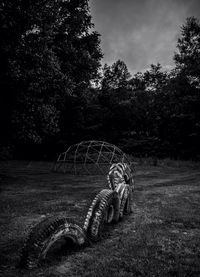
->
{"left": 84, "top": 189, "right": 120, "bottom": 242}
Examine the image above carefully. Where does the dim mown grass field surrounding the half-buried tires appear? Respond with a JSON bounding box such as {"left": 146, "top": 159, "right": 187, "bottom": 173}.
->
{"left": 0, "top": 161, "right": 200, "bottom": 277}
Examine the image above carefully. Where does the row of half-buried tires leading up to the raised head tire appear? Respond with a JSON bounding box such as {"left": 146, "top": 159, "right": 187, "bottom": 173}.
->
{"left": 19, "top": 183, "right": 131, "bottom": 268}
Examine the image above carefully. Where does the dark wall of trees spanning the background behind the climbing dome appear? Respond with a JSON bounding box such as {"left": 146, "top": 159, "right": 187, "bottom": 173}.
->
{"left": 0, "top": 0, "right": 200, "bottom": 159}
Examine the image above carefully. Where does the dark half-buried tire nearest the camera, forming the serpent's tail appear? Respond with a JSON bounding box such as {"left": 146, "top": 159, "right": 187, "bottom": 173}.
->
{"left": 19, "top": 217, "right": 87, "bottom": 268}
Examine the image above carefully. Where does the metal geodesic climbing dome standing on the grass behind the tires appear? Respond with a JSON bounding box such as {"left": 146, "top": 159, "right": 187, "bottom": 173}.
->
{"left": 54, "top": 140, "right": 132, "bottom": 175}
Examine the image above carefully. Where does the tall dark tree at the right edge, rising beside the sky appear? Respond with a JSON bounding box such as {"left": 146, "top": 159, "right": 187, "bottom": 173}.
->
{"left": 153, "top": 17, "right": 200, "bottom": 158}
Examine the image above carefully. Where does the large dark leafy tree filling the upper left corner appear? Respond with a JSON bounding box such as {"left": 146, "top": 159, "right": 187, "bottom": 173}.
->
{"left": 0, "top": 0, "right": 102, "bottom": 146}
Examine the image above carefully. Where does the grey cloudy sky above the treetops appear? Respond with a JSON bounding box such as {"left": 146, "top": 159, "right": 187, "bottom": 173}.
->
{"left": 90, "top": 0, "right": 200, "bottom": 74}
